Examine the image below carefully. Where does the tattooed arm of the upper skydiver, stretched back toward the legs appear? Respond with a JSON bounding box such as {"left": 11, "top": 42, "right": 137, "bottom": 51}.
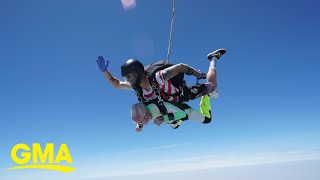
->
{"left": 162, "top": 63, "right": 202, "bottom": 81}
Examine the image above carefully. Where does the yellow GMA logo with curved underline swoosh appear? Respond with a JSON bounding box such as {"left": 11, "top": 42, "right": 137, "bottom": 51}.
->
{"left": 8, "top": 143, "right": 76, "bottom": 173}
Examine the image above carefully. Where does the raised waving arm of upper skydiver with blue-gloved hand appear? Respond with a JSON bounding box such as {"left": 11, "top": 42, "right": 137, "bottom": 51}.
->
{"left": 96, "top": 56, "right": 132, "bottom": 89}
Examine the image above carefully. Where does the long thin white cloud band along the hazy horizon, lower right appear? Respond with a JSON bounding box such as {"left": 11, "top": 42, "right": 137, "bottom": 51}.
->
{"left": 85, "top": 150, "right": 320, "bottom": 178}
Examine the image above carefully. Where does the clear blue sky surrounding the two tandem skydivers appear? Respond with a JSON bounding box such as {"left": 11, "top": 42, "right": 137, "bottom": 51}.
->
{"left": 0, "top": 0, "right": 320, "bottom": 179}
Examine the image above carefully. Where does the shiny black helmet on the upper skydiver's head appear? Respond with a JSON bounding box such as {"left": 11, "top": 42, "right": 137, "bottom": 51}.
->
{"left": 121, "top": 59, "right": 144, "bottom": 87}
